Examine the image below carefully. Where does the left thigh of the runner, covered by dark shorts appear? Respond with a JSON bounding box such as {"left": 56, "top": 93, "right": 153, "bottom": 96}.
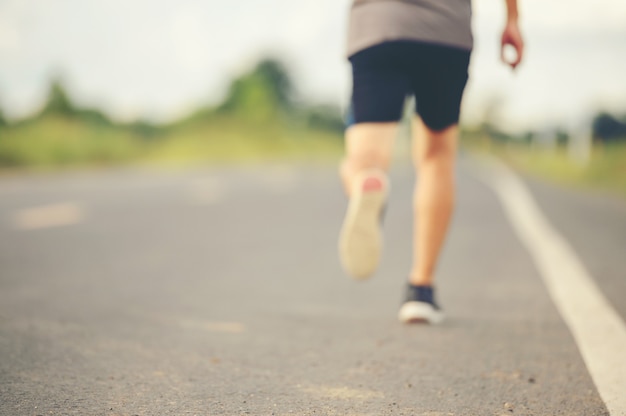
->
{"left": 350, "top": 44, "right": 411, "bottom": 123}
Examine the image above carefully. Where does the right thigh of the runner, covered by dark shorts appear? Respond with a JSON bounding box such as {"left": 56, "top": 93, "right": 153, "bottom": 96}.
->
{"left": 411, "top": 44, "right": 470, "bottom": 131}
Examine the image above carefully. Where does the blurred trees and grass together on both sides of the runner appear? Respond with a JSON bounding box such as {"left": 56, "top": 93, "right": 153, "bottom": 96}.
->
{"left": 0, "top": 59, "right": 626, "bottom": 197}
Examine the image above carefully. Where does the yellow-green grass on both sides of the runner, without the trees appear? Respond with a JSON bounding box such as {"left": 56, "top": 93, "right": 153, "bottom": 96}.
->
{"left": 7, "top": 116, "right": 626, "bottom": 201}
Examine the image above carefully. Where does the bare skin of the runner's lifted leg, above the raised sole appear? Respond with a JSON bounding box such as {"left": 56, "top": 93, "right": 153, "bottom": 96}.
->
{"left": 340, "top": 123, "right": 398, "bottom": 196}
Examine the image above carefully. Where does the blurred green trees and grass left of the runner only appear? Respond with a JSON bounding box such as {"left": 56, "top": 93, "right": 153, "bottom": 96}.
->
{"left": 0, "top": 59, "right": 343, "bottom": 171}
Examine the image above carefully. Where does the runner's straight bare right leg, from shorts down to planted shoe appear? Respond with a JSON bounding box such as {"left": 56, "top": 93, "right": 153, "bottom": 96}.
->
{"left": 409, "top": 118, "right": 458, "bottom": 286}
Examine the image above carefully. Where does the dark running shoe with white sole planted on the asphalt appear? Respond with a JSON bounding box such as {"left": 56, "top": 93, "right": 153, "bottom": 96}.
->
{"left": 398, "top": 283, "right": 444, "bottom": 325}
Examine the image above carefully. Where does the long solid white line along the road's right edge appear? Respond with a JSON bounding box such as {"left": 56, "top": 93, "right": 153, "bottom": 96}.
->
{"left": 476, "top": 160, "right": 626, "bottom": 416}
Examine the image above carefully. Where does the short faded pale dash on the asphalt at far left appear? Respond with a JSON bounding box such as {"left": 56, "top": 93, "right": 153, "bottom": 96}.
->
{"left": 14, "top": 202, "right": 84, "bottom": 230}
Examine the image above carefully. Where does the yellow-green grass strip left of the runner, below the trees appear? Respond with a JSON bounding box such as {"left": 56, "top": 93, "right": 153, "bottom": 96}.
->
{"left": 0, "top": 117, "right": 342, "bottom": 171}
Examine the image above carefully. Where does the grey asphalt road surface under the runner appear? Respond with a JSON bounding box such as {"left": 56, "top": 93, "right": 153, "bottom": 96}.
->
{"left": 0, "top": 163, "right": 626, "bottom": 416}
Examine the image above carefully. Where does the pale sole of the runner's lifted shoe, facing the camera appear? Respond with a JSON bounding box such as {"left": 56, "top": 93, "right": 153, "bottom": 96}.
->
{"left": 339, "top": 171, "right": 389, "bottom": 280}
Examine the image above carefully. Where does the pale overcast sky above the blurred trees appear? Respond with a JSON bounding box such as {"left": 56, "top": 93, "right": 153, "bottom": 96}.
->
{"left": 0, "top": 0, "right": 626, "bottom": 131}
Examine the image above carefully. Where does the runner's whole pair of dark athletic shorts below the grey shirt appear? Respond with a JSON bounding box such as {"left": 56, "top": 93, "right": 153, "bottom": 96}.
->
{"left": 348, "top": 41, "right": 471, "bottom": 130}
